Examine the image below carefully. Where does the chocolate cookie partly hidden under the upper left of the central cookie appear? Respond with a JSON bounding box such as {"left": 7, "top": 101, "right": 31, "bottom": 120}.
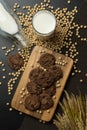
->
{"left": 29, "top": 67, "right": 43, "bottom": 81}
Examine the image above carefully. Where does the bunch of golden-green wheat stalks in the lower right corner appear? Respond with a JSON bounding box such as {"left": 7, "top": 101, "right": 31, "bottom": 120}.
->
{"left": 53, "top": 91, "right": 87, "bottom": 130}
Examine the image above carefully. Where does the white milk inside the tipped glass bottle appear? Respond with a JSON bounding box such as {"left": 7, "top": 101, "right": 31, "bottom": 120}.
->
{"left": 0, "top": 3, "right": 18, "bottom": 34}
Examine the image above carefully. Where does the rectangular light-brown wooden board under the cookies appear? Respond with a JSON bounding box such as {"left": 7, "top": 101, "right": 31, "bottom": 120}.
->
{"left": 11, "top": 46, "right": 73, "bottom": 121}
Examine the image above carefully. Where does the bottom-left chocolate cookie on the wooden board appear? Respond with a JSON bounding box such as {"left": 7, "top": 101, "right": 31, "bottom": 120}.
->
{"left": 25, "top": 95, "right": 40, "bottom": 111}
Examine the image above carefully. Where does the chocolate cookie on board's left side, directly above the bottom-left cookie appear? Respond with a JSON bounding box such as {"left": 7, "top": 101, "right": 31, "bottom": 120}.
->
{"left": 27, "top": 81, "right": 42, "bottom": 95}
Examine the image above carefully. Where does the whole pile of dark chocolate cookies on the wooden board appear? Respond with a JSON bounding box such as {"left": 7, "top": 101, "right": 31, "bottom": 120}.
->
{"left": 25, "top": 53, "right": 63, "bottom": 111}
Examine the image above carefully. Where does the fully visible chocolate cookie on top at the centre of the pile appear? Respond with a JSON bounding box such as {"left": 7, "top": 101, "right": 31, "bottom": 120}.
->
{"left": 36, "top": 71, "right": 54, "bottom": 89}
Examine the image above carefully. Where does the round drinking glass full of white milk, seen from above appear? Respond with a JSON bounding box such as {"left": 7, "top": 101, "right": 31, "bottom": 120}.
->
{"left": 32, "top": 10, "right": 56, "bottom": 40}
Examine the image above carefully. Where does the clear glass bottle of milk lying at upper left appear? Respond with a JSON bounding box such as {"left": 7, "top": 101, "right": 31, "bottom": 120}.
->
{"left": 0, "top": 0, "right": 27, "bottom": 47}
